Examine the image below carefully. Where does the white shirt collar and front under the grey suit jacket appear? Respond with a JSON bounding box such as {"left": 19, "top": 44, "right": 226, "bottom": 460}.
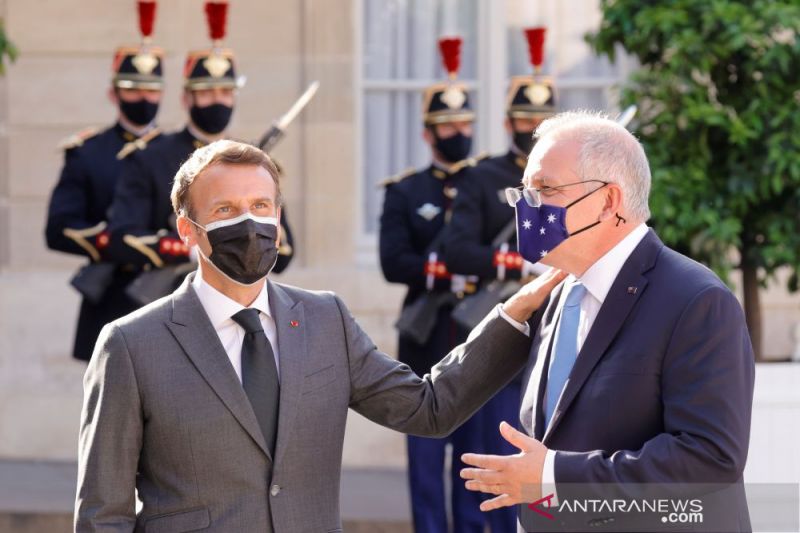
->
{"left": 192, "top": 265, "right": 280, "bottom": 382}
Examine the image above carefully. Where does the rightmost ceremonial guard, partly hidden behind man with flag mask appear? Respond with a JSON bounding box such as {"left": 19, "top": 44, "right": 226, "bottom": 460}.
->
{"left": 444, "top": 28, "right": 556, "bottom": 532}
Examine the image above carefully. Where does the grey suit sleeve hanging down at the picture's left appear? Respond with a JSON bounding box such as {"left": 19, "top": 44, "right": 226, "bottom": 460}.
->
{"left": 75, "top": 325, "right": 143, "bottom": 533}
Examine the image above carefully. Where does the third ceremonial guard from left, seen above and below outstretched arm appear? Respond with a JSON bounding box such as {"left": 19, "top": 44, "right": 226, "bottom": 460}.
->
{"left": 380, "top": 38, "right": 484, "bottom": 533}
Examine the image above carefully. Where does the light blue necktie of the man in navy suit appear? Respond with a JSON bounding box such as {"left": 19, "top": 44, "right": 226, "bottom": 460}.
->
{"left": 544, "top": 282, "right": 586, "bottom": 428}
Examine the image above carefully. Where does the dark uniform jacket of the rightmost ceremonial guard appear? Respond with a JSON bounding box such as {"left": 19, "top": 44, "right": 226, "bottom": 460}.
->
{"left": 444, "top": 151, "right": 527, "bottom": 280}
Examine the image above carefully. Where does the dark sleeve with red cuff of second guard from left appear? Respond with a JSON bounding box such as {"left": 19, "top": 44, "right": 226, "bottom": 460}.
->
{"left": 108, "top": 154, "right": 189, "bottom": 268}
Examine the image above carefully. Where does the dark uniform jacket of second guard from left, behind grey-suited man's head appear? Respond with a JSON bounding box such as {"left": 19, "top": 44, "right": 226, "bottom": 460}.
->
{"left": 109, "top": 128, "right": 293, "bottom": 272}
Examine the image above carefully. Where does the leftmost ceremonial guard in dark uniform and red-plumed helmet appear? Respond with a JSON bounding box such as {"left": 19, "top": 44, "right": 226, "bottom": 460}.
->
{"left": 45, "top": 0, "right": 164, "bottom": 361}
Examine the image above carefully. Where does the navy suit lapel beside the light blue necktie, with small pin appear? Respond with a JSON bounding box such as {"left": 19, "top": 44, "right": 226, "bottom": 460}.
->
{"left": 542, "top": 230, "right": 664, "bottom": 445}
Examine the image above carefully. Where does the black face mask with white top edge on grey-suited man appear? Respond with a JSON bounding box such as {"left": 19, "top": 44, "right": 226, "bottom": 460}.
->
{"left": 191, "top": 213, "right": 278, "bottom": 285}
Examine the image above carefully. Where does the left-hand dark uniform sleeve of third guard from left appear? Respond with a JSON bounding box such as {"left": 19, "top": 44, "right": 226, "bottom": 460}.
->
{"left": 379, "top": 185, "right": 428, "bottom": 287}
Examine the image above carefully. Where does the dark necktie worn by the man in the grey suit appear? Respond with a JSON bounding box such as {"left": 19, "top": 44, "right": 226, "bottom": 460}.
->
{"left": 231, "top": 309, "right": 280, "bottom": 458}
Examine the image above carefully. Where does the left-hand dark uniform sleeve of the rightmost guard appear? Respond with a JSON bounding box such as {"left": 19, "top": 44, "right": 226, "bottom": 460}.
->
{"left": 444, "top": 172, "right": 497, "bottom": 279}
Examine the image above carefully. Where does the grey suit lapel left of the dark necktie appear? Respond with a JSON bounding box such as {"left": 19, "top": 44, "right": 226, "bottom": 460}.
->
{"left": 166, "top": 274, "right": 272, "bottom": 459}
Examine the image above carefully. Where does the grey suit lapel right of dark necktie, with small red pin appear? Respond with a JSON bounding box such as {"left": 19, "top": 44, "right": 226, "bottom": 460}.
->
{"left": 267, "top": 281, "right": 308, "bottom": 463}
